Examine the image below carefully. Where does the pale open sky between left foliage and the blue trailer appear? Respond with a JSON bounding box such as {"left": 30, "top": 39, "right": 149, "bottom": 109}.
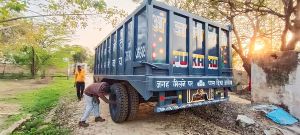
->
{"left": 69, "top": 0, "right": 139, "bottom": 51}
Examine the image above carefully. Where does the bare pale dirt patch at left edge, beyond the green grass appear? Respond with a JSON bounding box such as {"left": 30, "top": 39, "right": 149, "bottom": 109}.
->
{"left": 0, "top": 79, "right": 49, "bottom": 130}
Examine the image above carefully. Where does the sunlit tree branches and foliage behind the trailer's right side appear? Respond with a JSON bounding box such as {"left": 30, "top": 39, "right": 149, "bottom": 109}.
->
{"left": 157, "top": 0, "right": 300, "bottom": 76}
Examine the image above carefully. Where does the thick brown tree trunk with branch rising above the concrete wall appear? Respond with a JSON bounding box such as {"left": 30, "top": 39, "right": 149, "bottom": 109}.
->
{"left": 245, "top": 0, "right": 300, "bottom": 51}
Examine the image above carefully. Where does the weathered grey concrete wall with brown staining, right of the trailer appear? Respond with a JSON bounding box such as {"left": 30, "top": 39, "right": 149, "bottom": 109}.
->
{"left": 251, "top": 52, "right": 300, "bottom": 119}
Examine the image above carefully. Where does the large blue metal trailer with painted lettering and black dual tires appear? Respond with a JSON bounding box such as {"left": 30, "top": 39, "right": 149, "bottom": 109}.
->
{"left": 94, "top": 0, "right": 233, "bottom": 122}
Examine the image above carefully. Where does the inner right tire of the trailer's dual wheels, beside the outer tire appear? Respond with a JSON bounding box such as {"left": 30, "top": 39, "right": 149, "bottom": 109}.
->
{"left": 126, "top": 86, "right": 140, "bottom": 120}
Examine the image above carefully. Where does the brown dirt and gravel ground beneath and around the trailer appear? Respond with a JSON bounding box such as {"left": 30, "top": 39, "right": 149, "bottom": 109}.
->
{"left": 55, "top": 75, "right": 298, "bottom": 135}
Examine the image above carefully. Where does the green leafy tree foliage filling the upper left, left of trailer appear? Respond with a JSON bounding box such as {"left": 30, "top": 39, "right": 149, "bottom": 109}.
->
{"left": 0, "top": 0, "right": 126, "bottom": 76}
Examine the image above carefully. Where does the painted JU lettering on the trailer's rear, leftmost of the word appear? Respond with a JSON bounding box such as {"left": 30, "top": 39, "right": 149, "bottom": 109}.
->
{"left": 173, "top": 51, "right": 188, "bottom": 68}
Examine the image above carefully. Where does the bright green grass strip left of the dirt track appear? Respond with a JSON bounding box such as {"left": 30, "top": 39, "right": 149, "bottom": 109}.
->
{"left": 9, "top": 78, "right": 74, "bottom": 135}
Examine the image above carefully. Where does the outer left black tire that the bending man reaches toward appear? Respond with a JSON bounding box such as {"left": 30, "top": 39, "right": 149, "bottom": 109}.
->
{"left": 109, "top": 83, "right": 128, "bottom": 123}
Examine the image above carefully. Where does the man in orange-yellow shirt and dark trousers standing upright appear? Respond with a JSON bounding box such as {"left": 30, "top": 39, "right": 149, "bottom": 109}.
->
{"left": 75, "top": 65, "right": 85, "bottom": 101}
